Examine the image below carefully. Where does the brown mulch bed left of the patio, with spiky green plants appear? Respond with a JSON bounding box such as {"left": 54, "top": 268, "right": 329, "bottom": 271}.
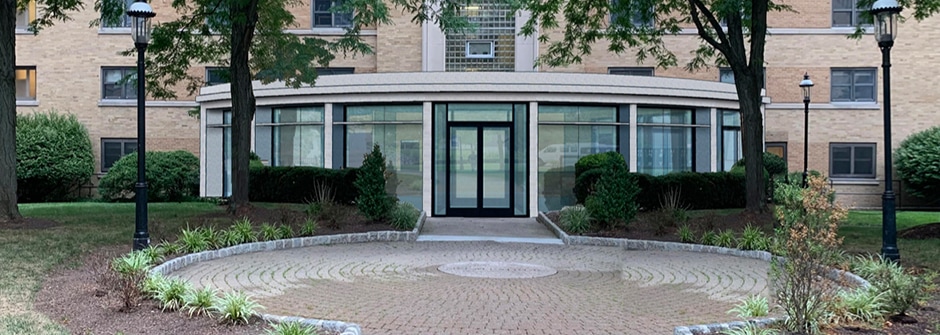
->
{"left": 33, "top": 206, "right": 392, "bottom": 335}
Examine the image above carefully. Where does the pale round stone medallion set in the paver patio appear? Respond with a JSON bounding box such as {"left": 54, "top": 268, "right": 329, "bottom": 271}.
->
{"left": 437, "top": 262, "right": 558, "bottom": 279}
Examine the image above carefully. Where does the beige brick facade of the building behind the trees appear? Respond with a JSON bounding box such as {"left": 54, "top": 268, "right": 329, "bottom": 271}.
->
{"left": 16, "top": 0, "right": 940, "bottom": 207}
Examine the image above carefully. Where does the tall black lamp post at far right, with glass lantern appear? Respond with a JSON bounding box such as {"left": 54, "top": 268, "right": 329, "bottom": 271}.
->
{"left": 870, "top": 0, "right": 901, "bottom": 261}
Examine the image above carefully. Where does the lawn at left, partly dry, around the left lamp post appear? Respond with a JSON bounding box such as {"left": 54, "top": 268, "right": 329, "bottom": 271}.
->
{"left": 0, "top": 203, "right": 223, "bottom": 334}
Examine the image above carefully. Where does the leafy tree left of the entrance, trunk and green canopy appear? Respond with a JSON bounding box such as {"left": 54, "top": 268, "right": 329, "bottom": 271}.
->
{"left": 107, "top": 0, "right": 390, "bottom": 212}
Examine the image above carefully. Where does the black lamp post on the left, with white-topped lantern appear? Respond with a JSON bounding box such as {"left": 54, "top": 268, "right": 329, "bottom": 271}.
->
{"left": 127, "top": 1, "right": 156, "bottom": 250}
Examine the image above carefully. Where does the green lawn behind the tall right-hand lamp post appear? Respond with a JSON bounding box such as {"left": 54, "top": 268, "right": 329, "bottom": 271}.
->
{"left": 839, "top": 211, "right": 940, "bottom": 271}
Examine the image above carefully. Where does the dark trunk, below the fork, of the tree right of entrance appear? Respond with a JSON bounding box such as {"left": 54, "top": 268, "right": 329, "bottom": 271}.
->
{"left": 735, "top": 67, "right": 767, "bottom": 213}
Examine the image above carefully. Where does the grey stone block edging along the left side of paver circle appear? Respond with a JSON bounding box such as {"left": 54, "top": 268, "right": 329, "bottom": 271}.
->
{"left": 150, "top": 211, "right": 427, "bottom": 335}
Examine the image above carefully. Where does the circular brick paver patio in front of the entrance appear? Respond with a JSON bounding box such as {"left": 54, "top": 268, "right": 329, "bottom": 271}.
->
{"left": 172, "top": 242, "right": 769, "bottom": 335}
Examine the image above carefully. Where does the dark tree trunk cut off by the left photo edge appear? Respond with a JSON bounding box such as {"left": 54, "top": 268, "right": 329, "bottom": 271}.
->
{"left": 0, "top": 0, "right": 20, "bottom": 222}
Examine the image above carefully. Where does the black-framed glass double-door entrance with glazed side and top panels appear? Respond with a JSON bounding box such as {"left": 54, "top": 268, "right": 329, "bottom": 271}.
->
{"left": 433, "top": 104, "right": 528, "bottom": 217}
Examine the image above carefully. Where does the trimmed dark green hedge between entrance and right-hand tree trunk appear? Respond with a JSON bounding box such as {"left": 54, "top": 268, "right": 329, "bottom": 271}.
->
{"left": 634, "top": 172, "right": 746, "bottom": 210}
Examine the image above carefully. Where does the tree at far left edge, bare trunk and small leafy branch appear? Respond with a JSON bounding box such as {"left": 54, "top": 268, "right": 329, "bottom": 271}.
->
{"left": 0, "top": 0, "right": 82, "bottom": 222}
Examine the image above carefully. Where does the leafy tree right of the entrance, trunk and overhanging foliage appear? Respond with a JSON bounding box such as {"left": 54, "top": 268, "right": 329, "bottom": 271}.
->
{"left": 517, "top": 0, "right": 940, "bottom": 212}
